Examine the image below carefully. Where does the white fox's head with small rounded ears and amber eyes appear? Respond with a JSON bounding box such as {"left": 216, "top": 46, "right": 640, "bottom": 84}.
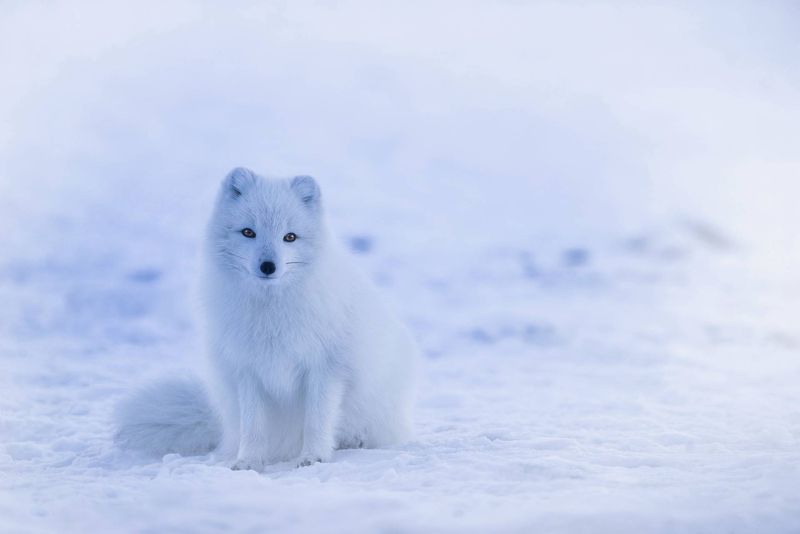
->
{"left": 209, "top": 167, "right": 326, "bottom": 285}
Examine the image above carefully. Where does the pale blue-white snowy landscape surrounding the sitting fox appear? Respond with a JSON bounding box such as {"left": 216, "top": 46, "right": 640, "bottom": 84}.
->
{"left": 0, "top": 2, "right": 800, "bottom": 532}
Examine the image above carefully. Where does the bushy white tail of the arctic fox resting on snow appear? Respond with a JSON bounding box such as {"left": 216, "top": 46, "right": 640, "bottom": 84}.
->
{"left": 114, "top": 378, "right": 222, "bottom": 456}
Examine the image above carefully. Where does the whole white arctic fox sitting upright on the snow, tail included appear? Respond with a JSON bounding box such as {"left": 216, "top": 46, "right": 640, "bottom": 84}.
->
{"left": 115, "top": 168, "right": 418, "bottom": 470}
